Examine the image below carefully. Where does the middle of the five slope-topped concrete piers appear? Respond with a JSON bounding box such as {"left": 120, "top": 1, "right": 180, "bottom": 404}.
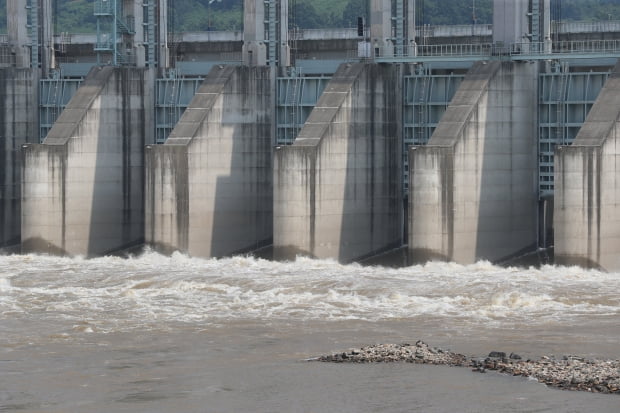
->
{"left": 274, "top": 63, "right": 403, "bottom": 262}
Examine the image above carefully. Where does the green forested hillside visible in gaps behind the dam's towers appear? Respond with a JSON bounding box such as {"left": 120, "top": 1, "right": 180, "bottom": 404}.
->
{"left": 0, "top": 0, "right": 620, "bottom": 33}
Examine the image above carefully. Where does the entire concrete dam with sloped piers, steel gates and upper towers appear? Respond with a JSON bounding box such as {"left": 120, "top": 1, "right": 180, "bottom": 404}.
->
{"left": 0, "top": 0, "right": 620, "bottom": 271}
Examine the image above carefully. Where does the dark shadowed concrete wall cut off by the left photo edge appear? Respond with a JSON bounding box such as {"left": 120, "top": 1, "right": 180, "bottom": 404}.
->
{"left": 0, "top": 68, "right": 38, "bottom": 248}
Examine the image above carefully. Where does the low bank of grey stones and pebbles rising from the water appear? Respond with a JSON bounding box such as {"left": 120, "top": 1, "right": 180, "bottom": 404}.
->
{"left": 309, "top": 341, "right": 620, "bottom": 394}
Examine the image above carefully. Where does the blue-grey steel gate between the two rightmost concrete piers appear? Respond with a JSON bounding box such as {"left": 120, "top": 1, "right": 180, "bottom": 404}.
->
{"left": 538, "top": 63, "right": 611, "bottom": 198}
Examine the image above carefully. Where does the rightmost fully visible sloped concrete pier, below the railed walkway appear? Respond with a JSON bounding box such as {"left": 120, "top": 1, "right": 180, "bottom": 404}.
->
{"left": 409, "top": 62, "right": 537, "bottom": 264}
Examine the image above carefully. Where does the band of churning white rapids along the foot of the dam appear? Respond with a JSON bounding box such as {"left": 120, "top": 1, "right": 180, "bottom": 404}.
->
{"left": 0, "top": 251, "right": 620, "bottom": 332}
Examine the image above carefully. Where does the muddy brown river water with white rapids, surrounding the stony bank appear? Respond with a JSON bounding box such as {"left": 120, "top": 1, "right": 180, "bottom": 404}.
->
{"left": 0, "top": 252, "right": 620, "bottom": 413}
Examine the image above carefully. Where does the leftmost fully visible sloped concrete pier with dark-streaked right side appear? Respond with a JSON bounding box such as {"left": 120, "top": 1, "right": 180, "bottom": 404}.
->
{"left": 22, "top": 67, "right": 151, "bottom": 256}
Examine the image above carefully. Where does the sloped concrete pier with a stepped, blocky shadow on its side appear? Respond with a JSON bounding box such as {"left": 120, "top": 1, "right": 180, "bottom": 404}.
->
{"left": 146, "top": 66, "right": 274, "bottom": 257}
